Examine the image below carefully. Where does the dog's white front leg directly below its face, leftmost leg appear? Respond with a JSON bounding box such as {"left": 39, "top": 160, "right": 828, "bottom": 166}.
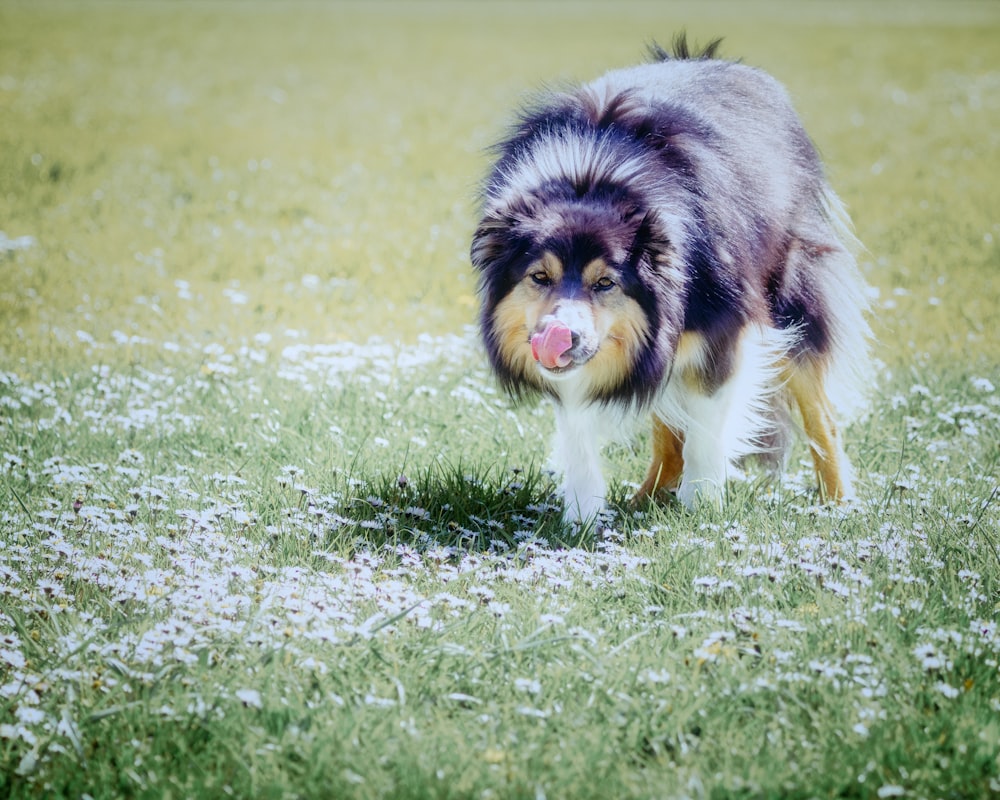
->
{"left": 552, "top": 405, "right": 607, "bottom": 523}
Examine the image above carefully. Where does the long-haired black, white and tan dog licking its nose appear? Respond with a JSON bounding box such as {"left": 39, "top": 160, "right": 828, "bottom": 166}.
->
{"left": 471, "top": 36, "right": 870, "bottom": 520}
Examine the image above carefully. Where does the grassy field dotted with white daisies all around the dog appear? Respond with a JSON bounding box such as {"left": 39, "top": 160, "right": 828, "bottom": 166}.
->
{"left": 0, "top": 0, "right": 1000, "bottom": 798}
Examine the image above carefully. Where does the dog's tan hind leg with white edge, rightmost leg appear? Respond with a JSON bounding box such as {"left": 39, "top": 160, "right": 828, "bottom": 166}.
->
{"left": 786, "top": 357, "right": 854, "bottom": 502}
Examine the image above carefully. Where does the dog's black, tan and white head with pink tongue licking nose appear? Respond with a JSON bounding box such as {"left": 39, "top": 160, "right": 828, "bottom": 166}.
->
{"left": 472, "top": 194, "right": 673, "bottom": 403}
